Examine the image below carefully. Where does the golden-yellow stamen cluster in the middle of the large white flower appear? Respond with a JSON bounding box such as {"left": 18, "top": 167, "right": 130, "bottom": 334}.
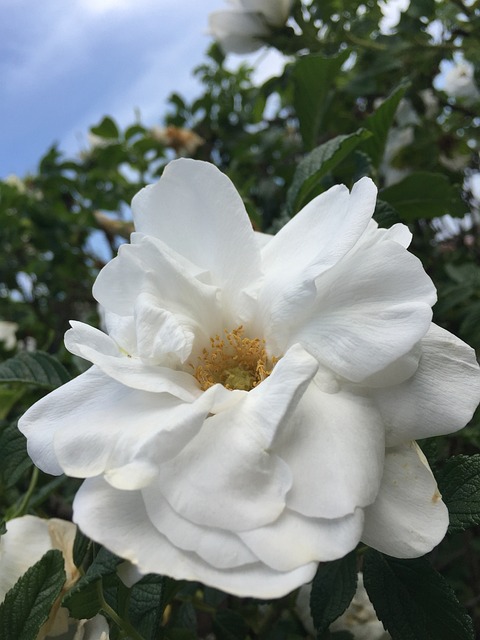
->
{"left": 192, "top": 326, "right": 278, "bottom": 391}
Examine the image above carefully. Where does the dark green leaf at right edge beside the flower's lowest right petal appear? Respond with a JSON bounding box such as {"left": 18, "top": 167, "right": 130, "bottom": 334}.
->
{"left": 437, "top": 454, "right": 480, "bottom": 531}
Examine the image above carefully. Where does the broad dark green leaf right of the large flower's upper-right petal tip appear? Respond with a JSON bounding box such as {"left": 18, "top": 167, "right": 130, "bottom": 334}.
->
{"left": 379, "top": 171, "right": 464, "bottom": 222}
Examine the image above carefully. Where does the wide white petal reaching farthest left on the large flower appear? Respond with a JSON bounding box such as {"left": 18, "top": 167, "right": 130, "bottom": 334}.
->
{"left": 19, "top": 367, "right": 214, "bottom": 486}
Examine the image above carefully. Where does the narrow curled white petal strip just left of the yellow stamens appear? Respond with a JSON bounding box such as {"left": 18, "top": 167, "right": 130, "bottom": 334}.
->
{"left": 65, "top": 320, "right": 201, "bottom": 402}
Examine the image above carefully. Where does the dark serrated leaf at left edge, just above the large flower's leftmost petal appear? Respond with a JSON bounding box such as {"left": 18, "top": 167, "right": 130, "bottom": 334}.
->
{"left": 0, "top": 351, "right": 70, "bottom": 389}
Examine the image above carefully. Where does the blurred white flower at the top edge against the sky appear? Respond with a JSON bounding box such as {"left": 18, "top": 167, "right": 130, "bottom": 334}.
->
{"left": 208, "top": 0, "right": 293, "bottom": 53}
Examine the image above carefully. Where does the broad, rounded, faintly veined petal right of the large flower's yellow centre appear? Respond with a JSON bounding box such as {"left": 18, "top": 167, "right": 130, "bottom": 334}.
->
{"left": 290, "top": 230, "right": 436, "bottom": 382}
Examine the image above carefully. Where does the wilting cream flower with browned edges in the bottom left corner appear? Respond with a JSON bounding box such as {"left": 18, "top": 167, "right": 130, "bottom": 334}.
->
{"left": 0, "top": 515, "right": 109, "bottom": 640}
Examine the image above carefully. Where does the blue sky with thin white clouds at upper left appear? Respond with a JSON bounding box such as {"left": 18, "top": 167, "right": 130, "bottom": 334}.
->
{"left": 0, "top": 0, "right": 284, "bottom": 178}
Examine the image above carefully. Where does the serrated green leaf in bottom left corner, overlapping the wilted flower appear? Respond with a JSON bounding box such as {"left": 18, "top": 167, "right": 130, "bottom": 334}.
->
{"left": 0, "top": 549, "right": 65, "bottom": 640}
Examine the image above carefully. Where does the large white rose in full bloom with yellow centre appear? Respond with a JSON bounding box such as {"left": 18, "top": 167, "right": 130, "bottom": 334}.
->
{"left": 19, "top": 159, "right": 480, "bottom": 598}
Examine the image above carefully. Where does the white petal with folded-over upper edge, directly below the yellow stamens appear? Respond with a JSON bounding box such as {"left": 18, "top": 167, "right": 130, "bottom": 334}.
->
{"left": 159, "top": 346, "right": 317, "bottom": 531}
